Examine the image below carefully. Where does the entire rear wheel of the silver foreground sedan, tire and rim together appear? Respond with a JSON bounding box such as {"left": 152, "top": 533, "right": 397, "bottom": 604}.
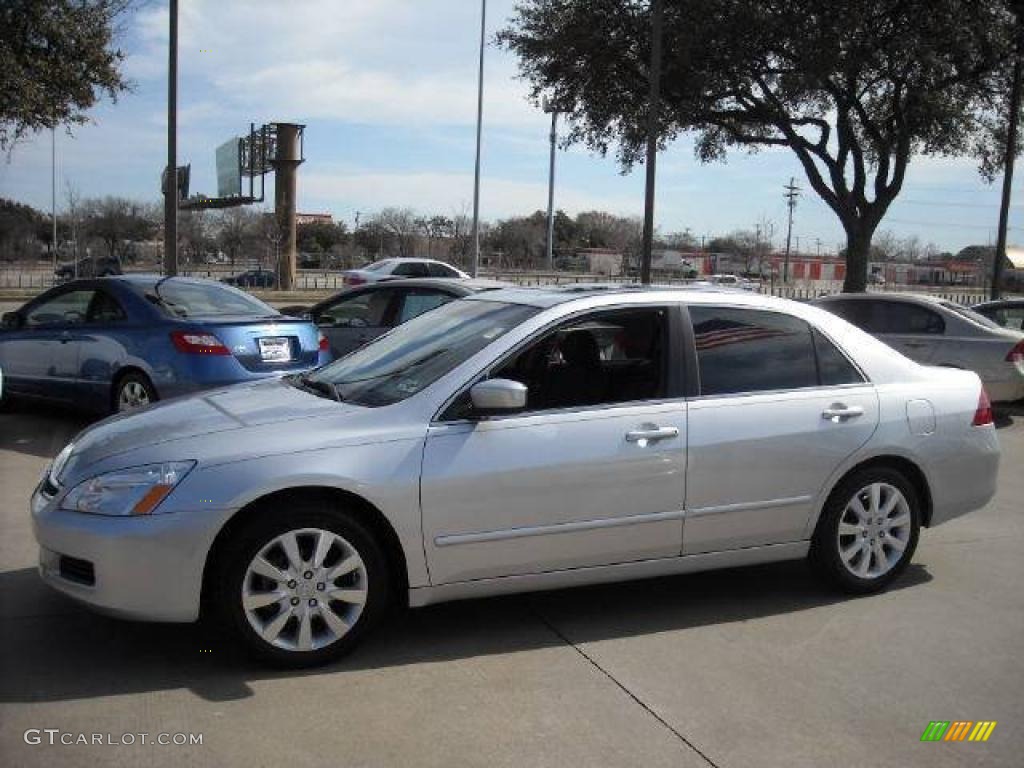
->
{"left": 811, "top": 467, "right": 921, "bottom": 593}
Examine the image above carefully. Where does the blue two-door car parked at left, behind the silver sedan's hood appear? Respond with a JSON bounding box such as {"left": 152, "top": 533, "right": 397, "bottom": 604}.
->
{"left": 0, "top": 274, "right": 331, "bottom": 412}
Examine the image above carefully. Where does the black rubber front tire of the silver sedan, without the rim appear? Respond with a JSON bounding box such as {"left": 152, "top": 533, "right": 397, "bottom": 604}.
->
{"left": 209, "top": 500, "right": 391, "bottom": 669}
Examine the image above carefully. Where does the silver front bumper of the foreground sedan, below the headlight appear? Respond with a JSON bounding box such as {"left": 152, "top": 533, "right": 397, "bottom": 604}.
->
{"left": 32, "top": 489, "right": 229, "bottom": 622}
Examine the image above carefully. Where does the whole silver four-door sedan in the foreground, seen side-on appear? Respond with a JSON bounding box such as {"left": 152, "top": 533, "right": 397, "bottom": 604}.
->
{"left": 32, "top": 289, "right": 999, "bottom": 666}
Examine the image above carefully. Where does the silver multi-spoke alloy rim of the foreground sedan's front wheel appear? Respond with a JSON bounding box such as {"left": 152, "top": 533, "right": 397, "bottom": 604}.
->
{"left": 241, "top": 528, "right": 369, "bottom": 651}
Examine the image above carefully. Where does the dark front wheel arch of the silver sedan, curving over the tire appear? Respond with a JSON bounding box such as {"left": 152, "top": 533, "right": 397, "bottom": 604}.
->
{"left": 200, "top": 485, "right": 409, "bottom": 613}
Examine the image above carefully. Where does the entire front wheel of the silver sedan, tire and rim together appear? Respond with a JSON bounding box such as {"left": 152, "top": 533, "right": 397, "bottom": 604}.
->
{"left": 214, "top": 501, "right": 389, "bottom": 667}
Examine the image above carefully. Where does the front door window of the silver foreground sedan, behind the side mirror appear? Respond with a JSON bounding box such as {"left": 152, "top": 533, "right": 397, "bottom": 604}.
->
{"left": 489, "top": 307, "right": 668, "bottom": 411}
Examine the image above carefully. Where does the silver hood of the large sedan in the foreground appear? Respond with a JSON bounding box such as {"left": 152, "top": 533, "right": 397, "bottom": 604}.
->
{"left": 59, "top": 379, "right": 366, "bottom": 482}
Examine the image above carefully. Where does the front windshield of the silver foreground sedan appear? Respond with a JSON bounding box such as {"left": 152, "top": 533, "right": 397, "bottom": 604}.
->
{"left": 308, "top": 301, "right": 539, "bottom": 407}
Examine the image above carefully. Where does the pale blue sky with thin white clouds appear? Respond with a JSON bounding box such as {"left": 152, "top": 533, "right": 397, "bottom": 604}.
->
{"left": 0, "top": 0, "right": 1024, "bottom": 256}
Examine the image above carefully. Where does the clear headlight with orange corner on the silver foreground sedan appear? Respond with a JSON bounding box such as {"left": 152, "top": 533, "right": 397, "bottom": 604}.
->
{"left": 60, "top": 462, "right": 196, "bottom": 516}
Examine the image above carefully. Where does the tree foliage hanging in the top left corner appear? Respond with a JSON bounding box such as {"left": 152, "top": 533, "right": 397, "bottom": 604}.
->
{"left": 0, "top": 0, "right": 131, "bottom": 150}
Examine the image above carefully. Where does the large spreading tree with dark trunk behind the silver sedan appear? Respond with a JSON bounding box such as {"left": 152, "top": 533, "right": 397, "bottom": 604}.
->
{"left": 499, "top": 0, "right": 1012, "bottom": 291}
